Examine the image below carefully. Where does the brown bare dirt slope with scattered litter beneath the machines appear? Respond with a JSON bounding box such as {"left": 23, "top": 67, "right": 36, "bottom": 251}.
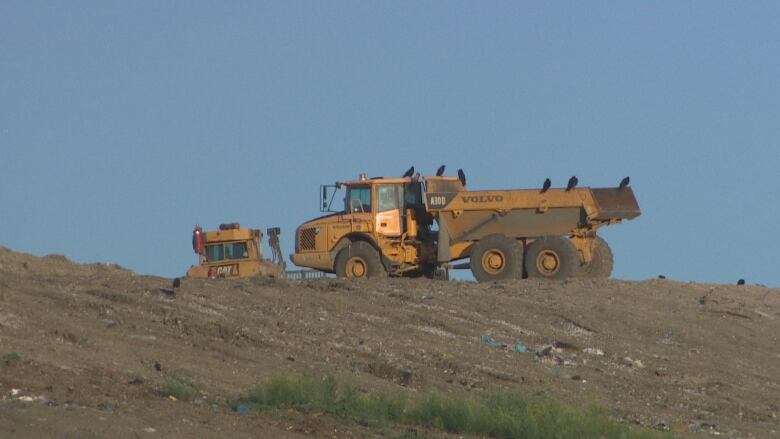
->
{"left": 0, "top": 247, "right": 780, "bottom": 438}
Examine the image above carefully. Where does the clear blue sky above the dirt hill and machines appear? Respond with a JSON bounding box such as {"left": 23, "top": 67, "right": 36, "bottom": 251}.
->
{"left": 0, "top": 1, "right": 780, "bottom": 286}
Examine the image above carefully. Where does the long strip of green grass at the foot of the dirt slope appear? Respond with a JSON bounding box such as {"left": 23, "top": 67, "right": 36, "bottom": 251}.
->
{"left": 232, "top": 375, "right": 670, "bottom": 439}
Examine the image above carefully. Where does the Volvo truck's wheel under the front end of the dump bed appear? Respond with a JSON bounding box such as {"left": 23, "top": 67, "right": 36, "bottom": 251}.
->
{"left": 471, "top": 235, "right": 523, "bottom": 282}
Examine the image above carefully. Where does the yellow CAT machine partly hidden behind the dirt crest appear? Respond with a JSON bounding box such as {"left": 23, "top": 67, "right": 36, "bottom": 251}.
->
{"left": 187, "top": 223, "right": 284, "bottom": 279}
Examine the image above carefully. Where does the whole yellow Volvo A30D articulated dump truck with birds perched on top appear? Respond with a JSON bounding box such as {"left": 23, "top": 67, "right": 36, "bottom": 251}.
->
{"left": 290, "top": 166, "right": 641, "bottom": 281}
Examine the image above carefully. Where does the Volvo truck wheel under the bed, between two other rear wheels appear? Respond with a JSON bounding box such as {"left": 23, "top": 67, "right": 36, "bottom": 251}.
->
{"left": 525, "top": 236, "right": 580, "bottom": 280}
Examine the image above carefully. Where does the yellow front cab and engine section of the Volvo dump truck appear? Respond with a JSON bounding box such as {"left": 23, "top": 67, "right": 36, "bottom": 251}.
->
{"left": 290, "top": 175, "right": 435, "bottom": 277}
